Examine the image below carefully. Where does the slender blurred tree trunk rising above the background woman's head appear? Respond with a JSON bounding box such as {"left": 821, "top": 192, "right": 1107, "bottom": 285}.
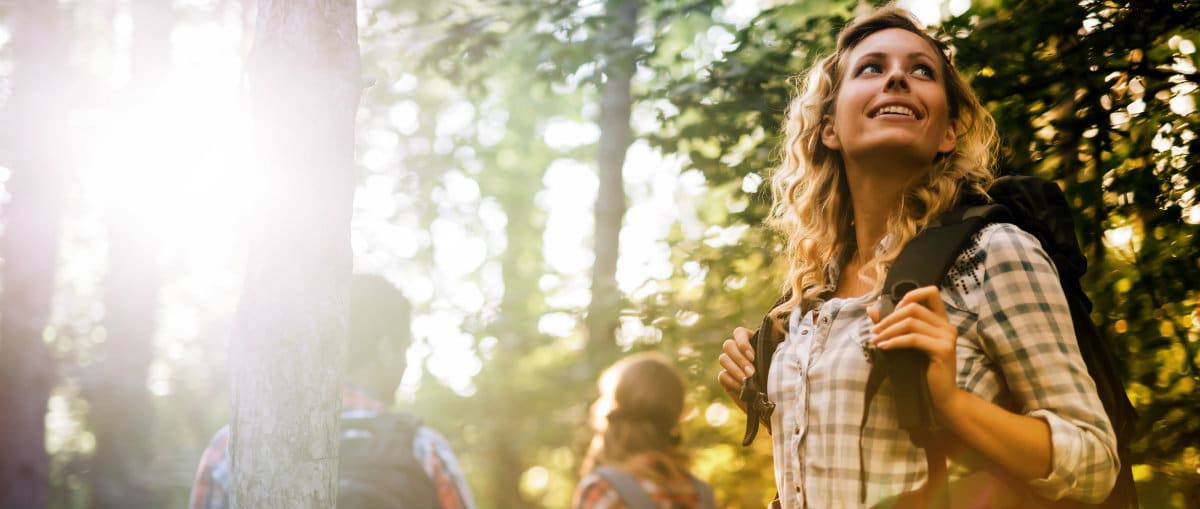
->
{"left": 587, "top": 0, "right": 642, "bottom": 366}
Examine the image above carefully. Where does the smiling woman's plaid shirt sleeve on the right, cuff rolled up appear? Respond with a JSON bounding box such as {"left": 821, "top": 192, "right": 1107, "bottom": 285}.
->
{"left": 976, "top": 224, "right": 1120, "bottom": 503}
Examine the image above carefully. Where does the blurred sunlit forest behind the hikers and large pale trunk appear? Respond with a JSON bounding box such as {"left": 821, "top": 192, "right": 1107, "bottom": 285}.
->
{"left": 0, "top": 0, "right": 1200, "bottom": 508}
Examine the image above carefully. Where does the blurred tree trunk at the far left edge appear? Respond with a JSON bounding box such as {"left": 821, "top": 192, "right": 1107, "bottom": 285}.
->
{"left": 0, "top": 0, "right": 70, "bottom": 509}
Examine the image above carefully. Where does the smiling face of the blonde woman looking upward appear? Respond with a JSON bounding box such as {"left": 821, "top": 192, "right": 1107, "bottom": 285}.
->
{"left": 821, "top": 29, "right": 955, "bottom": 164}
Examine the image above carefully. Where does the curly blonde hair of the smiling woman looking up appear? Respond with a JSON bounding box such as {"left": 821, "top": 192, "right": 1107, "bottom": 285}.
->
{"left": 767, "top": 6, "right": 997, "bottom": 327}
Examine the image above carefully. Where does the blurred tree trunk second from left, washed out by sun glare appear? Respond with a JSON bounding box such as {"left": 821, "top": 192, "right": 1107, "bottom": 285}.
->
{"left": 85, "top": 0, "right": 172, "bottom": 509}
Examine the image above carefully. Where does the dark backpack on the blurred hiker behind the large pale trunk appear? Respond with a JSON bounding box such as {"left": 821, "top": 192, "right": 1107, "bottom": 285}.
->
{"left": 337, "top": 414, "right": 440, "bottom": 509}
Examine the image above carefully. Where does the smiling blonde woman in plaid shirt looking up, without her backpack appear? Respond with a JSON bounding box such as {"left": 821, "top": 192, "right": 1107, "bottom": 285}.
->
{"left": 718, "top": 7, "right": 1118, "bottom": 508}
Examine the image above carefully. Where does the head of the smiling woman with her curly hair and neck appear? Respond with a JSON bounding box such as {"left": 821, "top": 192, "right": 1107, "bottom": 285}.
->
{"left": 769, "top": 10, "right": 997, "bottom": 307}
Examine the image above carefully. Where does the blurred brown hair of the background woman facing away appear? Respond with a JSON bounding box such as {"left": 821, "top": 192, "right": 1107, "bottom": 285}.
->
{"left": 583, "top": 352, "right": 689, "bottom": 484}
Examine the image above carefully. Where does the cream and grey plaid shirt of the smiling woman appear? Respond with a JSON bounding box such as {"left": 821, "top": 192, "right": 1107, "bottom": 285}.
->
{"left": 768, "top": 223, "right": 1117, "bottom": 509}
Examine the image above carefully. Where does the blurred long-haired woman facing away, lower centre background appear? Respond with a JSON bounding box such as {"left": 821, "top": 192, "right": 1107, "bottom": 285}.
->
{"left": 572, "top": 353, "right": 715, "bottom": 509}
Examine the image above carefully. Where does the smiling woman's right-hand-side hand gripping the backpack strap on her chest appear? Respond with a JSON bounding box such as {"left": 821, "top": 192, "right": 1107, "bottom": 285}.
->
{"left": 868, "top": 286, "right": 959, "bottom": 412}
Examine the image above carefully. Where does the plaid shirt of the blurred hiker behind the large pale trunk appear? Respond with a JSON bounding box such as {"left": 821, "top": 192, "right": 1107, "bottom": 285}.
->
{"left": 187, "top": 388, "right": 475, "bottom": 509}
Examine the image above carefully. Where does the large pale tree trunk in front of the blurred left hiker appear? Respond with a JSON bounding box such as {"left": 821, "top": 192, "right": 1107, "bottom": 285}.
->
{"left": 230, "top": 0, "right": 362, "bottom": 509}
